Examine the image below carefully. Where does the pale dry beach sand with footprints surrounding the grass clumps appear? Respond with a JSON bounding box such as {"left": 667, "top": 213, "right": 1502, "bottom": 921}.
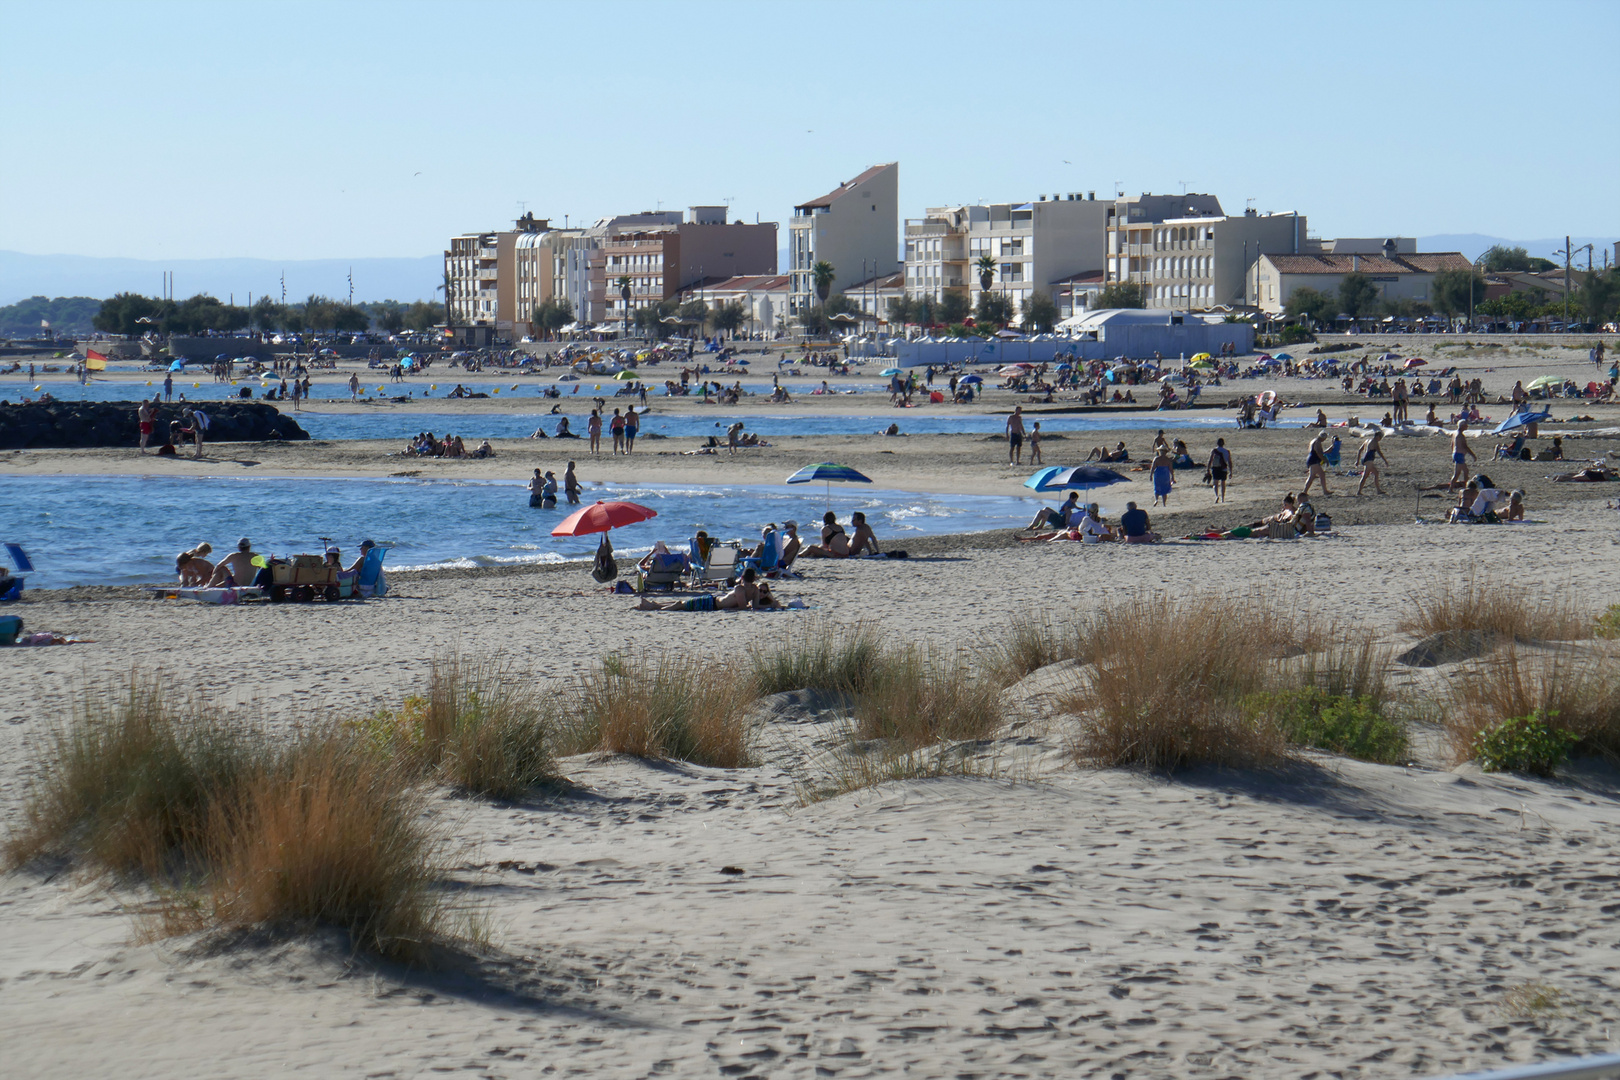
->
{"left": 0, "top": 335, "right": 1620, "bottom": 1077}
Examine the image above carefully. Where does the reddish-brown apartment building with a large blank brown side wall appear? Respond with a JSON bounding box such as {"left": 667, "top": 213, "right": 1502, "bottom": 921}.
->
{"left": 582, "top": 206, "right": 776, "bottom": 322}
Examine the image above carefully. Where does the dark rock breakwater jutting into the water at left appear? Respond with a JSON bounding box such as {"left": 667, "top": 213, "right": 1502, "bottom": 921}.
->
{"left": 0, "top": 400, "right": 309, "bottom": 450}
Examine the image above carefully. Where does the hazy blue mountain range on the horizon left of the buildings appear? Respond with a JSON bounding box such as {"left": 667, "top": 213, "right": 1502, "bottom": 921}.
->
{"left": 0, "top": 251, "right": 444, "bottom": 304}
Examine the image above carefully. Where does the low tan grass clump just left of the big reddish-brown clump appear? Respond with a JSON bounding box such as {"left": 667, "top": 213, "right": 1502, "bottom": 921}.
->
{"left": 855, "top": 646, "right": 1001, "bottom": 750}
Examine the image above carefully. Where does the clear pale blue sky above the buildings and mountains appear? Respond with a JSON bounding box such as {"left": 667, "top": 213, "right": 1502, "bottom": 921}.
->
{"left": 0, "top": 0, "right": 1620, "bottom": 259}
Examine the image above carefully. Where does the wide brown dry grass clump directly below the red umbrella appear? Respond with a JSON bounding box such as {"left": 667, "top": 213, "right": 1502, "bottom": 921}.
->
{"left": 565, "top": 653, "right": 753, "bottom": 769}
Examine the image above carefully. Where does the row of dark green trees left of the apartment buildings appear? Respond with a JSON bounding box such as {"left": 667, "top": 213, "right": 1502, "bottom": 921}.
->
{"left": 91, "top": 293, "right": 444, "bottom": 337}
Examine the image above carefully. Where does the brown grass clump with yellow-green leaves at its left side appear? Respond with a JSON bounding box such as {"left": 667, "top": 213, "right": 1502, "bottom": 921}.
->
{"left": 361, "top": 653, "right": 559, "bottom": 798}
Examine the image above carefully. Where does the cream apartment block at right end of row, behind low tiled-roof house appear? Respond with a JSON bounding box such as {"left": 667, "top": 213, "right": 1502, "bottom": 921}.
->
{"left": 1105, "top": 194, "right": 1314, "bottom": 311}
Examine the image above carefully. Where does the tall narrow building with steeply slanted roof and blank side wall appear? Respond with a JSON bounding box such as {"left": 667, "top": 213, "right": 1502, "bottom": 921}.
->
{"left": 787, "top": 162, "right": 901, "bottom": 314}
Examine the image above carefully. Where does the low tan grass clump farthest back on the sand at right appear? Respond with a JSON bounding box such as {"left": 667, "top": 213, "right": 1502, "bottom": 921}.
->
{"left": 1398, "top": 573, "right": 1592, "bottom": 641}
